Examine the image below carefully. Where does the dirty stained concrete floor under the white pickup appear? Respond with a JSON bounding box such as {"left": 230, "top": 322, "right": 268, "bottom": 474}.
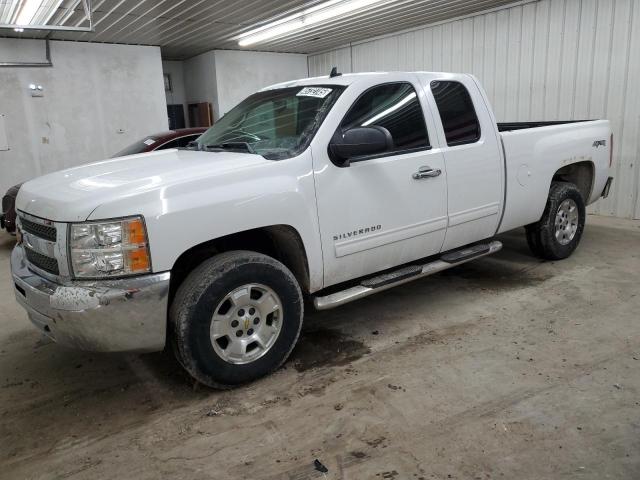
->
{"left": 0, "top": 216, "right": 640, "bottom": 480}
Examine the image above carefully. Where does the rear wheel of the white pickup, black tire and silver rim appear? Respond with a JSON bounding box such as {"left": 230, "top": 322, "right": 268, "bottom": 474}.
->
{"left": 526, "top": 182, "right": 586, "bottom": 260}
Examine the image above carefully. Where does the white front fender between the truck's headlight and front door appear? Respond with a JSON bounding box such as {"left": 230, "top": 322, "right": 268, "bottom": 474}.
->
{"left": 90, "top": 149, "right": 323, "bottom": 291}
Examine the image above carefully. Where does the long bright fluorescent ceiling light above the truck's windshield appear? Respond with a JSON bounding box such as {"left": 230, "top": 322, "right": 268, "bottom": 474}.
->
{"left": 238, "top": 0, "right": 382, "bottom": 47}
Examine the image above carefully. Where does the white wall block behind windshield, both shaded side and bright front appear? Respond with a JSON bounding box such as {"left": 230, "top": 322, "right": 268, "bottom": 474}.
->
{"left": 180, "top": 50, "right": 308, "bottom": 120}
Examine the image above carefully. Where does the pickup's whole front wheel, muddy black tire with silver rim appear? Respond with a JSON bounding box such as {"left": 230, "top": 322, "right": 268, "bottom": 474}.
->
{"left": 169, "top": 251, "right": 304, "bottom": 388}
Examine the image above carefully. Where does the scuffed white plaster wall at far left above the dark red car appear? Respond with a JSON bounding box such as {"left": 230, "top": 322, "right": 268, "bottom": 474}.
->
{"left": 0, "top": 38, "right": 168, "bottom": 193}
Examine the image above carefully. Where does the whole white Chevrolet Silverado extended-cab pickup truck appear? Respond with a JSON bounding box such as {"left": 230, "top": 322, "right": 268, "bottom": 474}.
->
{"left": 11, "top": 72, "right": 613, "bottom": 387}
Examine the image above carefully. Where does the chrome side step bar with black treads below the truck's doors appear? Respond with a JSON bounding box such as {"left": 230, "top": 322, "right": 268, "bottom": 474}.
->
{"left": 313, "top": 241, "right": 502, "bottom": 310}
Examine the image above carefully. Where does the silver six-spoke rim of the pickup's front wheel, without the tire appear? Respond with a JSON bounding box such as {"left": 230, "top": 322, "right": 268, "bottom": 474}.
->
{"left": 210, "top": 283, "right": 283, "bottom": 365}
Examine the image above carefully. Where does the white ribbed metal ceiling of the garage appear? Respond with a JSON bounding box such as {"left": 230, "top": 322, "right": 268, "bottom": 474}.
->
{"left": 0, "top": 0, "right": 514, "bottom": 60}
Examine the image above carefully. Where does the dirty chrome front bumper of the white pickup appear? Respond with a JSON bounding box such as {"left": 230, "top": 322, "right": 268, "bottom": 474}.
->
{"left": 11, "top": 245, "right": 170, "bottom": 352}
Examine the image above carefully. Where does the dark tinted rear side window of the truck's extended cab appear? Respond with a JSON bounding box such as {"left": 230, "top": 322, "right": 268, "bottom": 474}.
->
{"left": 431, "top": 80, "right": 480, "bottom": 147}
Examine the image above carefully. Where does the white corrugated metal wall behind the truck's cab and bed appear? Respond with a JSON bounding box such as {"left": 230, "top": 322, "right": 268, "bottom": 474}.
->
{"left": 309, "top": 0, "right": 640, "bottom": 218}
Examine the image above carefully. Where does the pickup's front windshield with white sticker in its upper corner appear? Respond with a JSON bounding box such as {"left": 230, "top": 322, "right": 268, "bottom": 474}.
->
{"left": 198, "top": 85, "right": 344, "bottom": 160}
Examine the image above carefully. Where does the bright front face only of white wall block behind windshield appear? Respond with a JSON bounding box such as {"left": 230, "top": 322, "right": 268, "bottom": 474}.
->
{"left": 215, "top": 50, "right": 308, "bottom": 116}
